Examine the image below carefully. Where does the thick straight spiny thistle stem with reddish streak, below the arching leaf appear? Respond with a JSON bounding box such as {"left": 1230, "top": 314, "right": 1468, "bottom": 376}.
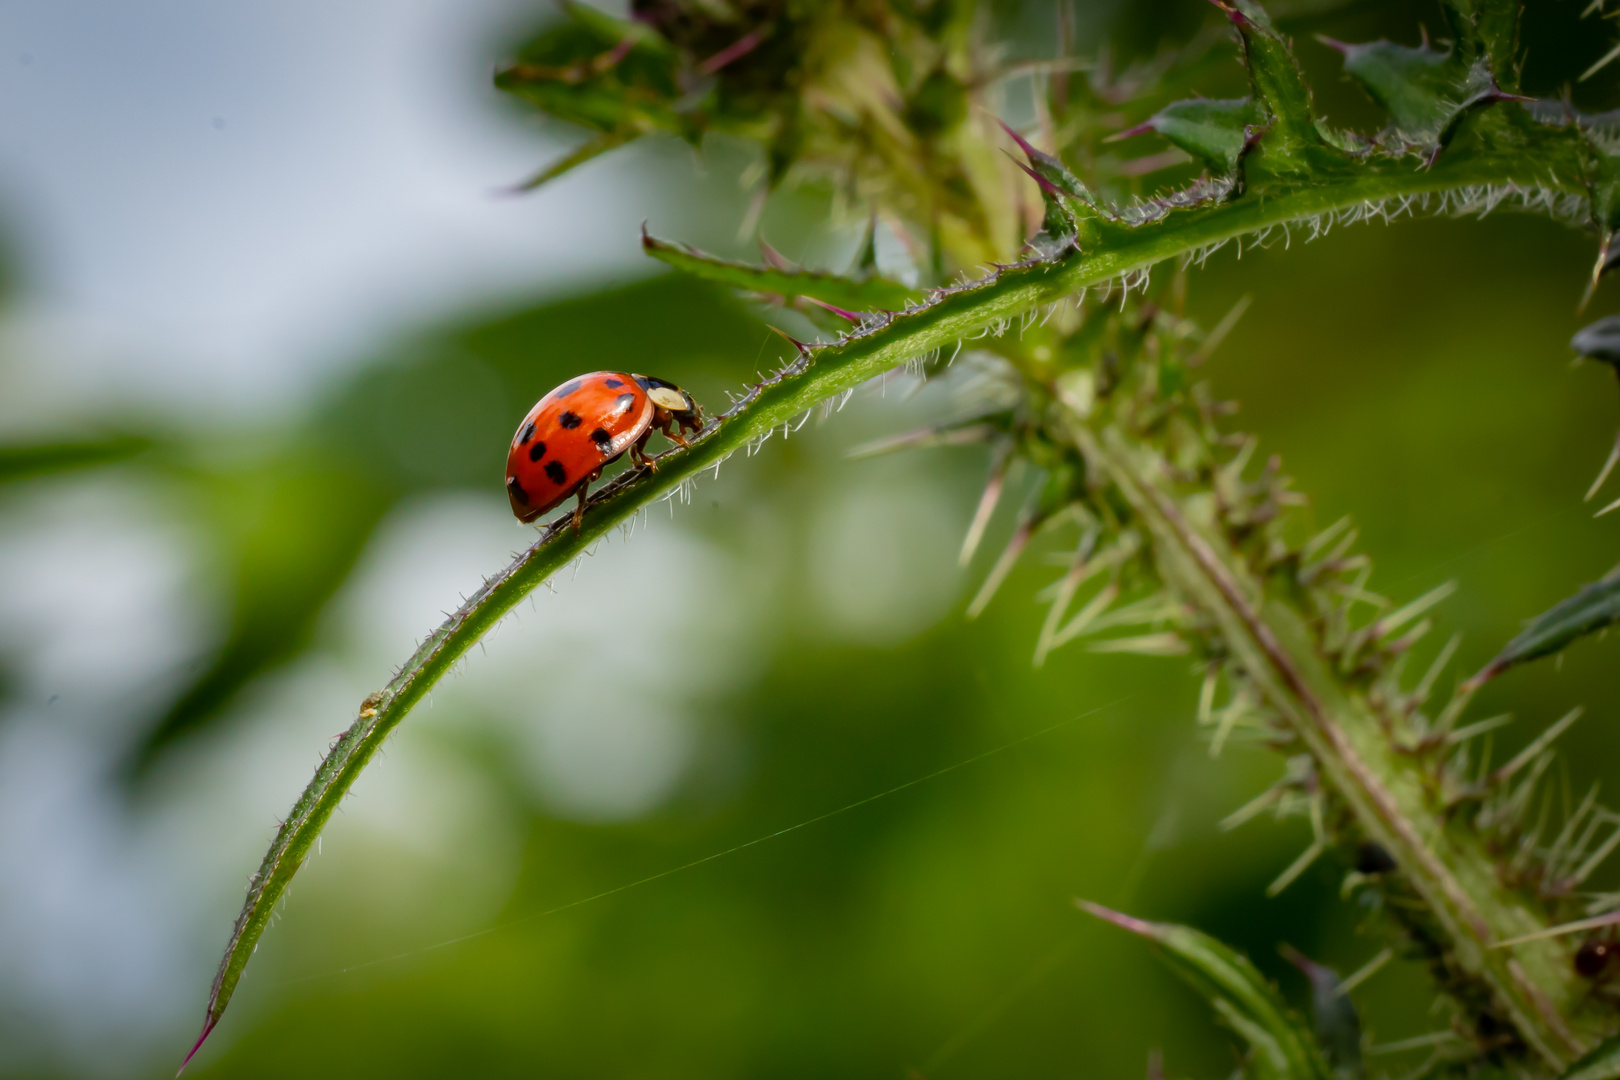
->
{"left": 1068, "top": 411, "right": 1605, "bottom": 1069}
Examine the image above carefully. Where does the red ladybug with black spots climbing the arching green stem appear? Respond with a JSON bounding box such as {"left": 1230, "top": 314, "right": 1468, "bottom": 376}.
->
{"left": 507, "top": 371, "right": 703, "bottom": 533}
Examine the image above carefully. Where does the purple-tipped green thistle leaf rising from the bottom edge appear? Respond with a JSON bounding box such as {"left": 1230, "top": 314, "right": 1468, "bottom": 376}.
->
{"left": 1076, "top": 900, "right": 1332, "bottom": 1080}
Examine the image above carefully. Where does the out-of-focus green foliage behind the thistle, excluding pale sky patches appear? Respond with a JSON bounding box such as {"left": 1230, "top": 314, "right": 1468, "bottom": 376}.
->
{"left": 9, "top": 2, "right": 1620, "bottom": 1078}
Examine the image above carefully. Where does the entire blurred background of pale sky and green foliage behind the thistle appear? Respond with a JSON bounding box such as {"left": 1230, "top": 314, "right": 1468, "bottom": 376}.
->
{"left": 0, "top": 0, "right": 1620, "bottom": 1080}
